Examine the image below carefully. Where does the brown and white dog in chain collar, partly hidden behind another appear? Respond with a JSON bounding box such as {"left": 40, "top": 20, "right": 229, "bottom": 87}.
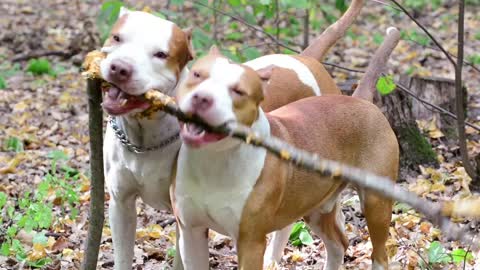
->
{"left": 101, "top": 0, "right": 363, "bottom": 270}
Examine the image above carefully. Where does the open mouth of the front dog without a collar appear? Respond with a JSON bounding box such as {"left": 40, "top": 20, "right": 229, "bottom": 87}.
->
{"left": 180, "top": 123, "right": 227, "bottom": 147}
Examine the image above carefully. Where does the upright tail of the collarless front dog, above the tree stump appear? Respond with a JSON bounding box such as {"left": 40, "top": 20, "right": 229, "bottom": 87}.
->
{"left": 352, "top": 27, "right": 400, "bottom": 102}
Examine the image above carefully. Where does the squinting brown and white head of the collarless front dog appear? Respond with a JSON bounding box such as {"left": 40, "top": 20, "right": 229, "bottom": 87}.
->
{"left": 177, "top": 47, "right": 263, "bottom": 147}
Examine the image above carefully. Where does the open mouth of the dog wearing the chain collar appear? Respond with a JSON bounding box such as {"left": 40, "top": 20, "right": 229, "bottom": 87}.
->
{"left": 102, "top": 85, "right": 150, "bottom": 115}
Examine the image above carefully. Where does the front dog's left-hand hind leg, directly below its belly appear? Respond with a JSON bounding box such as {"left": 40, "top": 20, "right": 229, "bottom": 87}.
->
{"left": 305, "top": 203, "right": 348, "bottom": 270}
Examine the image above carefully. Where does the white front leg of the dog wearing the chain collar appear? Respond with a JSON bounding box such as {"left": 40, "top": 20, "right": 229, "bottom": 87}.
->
{"left": 109, "top": 195, "right": 137, "bottom": 270}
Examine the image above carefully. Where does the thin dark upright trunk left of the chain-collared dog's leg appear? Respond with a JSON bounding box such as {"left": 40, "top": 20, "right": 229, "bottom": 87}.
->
{"left": 82, "top": 79, "right": 105, "bottom": 270}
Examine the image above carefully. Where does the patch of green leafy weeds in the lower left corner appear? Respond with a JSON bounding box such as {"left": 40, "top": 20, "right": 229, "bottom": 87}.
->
{"left": 0, "top": 150, "right": 80, "bottom": 268}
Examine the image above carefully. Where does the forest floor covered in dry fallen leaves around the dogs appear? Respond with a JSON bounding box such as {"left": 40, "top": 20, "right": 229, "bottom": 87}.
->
{"left": 0, "top": 0, "right": 480, "bottom": 269}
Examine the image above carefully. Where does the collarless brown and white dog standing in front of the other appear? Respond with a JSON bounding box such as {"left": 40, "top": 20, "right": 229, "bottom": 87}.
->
{"left": 171, "top": 48, "right": 399, "bottom": 270}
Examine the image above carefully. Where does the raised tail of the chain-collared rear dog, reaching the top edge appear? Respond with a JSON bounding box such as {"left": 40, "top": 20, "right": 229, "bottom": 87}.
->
{"left": 300, "top": 0, "right": 365, "bottom": 62}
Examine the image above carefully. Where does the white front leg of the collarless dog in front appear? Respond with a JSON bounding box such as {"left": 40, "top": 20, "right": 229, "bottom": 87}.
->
{"left": 179, "top": 225, "right": 210, "bottom": 270}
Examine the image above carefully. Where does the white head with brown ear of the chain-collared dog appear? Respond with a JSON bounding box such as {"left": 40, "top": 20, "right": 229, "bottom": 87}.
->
{"left": 100, "top": 8, "right": 193, "bottom": 115}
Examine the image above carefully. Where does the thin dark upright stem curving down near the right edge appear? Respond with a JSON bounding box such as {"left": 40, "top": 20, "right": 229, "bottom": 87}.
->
{"left": 455, "top": 0, "right": 479, "bottom": 182}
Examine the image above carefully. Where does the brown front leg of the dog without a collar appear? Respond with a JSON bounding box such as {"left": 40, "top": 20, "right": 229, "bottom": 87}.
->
{"left": 237, "top": 231, "right": 267, "bottom": 270}
